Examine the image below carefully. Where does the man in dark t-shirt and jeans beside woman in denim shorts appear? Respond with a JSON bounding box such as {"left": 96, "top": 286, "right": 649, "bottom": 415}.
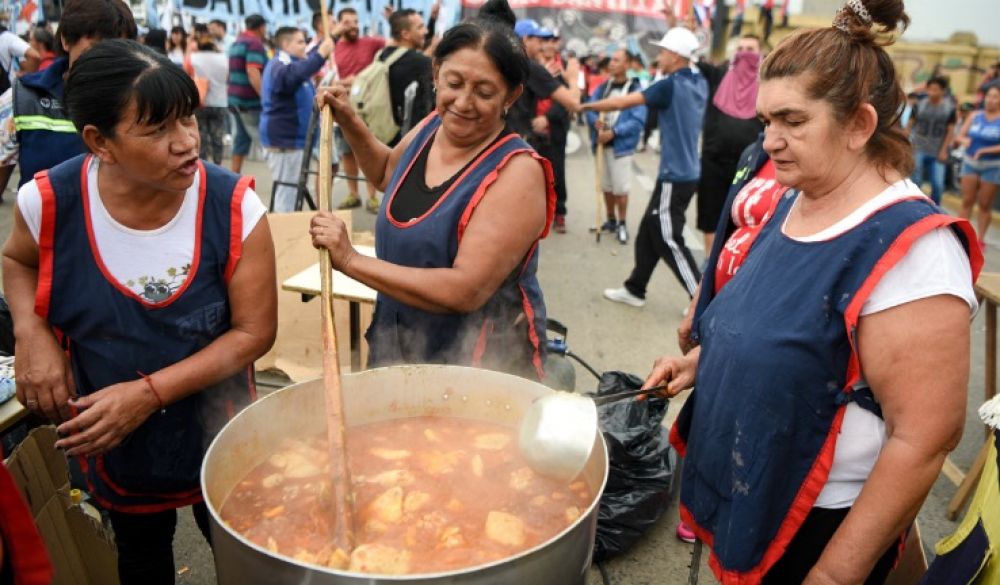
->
{"left": 906, "top": 77, "right": 956, "bottom": 205}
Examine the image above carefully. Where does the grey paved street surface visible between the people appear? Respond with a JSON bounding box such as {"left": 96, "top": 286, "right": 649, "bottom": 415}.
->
{"left": 0, "top": 129, "right": 1000, "bottom": 585}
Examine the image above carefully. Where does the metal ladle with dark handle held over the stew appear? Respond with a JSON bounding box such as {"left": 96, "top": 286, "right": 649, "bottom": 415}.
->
{"left": 518, "top": 386, "right": 666, "bottom": 482}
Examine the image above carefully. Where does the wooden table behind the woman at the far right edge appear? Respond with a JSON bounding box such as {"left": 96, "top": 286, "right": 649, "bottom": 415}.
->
{"left": 943, "top": 272, "right": 1000, "bottom": 520}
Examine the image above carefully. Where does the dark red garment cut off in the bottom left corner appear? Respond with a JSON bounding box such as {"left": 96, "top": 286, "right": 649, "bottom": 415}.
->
{"left": 0, "top": 466, "right": 54, "bottom": 585}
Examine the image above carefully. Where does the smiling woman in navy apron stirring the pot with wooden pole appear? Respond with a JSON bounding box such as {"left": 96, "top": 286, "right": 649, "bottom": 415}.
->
{"left": 310, "top": 0, "right": 555, "bottom": 379}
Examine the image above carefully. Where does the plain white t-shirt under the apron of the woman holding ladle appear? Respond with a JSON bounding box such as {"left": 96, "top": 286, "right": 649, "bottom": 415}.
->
{"left": 782, "top": 179, "right": 979, "bottom": 508}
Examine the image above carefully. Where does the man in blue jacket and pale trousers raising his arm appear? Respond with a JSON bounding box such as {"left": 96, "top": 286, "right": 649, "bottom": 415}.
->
{"left": 260, "top": 26, "right": 333, "bottom": 211}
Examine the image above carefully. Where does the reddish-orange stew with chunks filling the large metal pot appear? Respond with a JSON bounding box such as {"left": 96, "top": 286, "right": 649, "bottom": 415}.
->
{"left": 221, "top": 417, "right": 593, "bottom": 574}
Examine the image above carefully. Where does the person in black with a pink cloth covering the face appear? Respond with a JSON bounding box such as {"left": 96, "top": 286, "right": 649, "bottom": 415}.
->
{"left": 697, "top": 35, "right": 764, "bottom": 251}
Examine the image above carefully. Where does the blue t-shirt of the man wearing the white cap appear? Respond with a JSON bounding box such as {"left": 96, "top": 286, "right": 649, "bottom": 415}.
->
{"left": 642, "top": 67, "right": 708, "bottom": 183}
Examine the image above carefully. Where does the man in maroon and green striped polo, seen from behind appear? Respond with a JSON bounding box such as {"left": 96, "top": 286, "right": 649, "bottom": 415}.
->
{"left": 228, "top": 14, "right": 267, "bottom": 173}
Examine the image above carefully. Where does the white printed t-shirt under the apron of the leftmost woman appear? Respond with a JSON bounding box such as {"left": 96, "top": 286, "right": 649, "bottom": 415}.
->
{"left": 17, "top": 157, "right": 267, "bottom": 303}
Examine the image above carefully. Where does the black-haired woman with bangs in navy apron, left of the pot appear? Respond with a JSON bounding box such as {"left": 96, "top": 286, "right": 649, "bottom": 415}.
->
{"left": 3, "top": 40, "right": 277, "bottom": 585}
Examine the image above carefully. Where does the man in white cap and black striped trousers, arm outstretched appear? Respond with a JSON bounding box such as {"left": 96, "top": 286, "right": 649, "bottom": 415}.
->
{"left": 583, "top": 27, "right": 708, "bottom": 307}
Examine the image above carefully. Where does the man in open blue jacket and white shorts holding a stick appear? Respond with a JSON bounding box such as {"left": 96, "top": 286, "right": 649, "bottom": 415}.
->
{"left": 587, "top": 49, "right": 646, "bottom": 245}
